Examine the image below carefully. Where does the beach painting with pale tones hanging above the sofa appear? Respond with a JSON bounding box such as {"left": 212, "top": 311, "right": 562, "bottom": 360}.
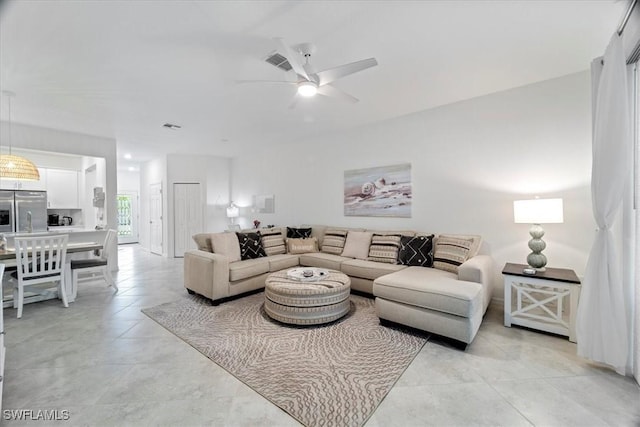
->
{"left": 344, "top": 163, "right": 412, "bottom": 218}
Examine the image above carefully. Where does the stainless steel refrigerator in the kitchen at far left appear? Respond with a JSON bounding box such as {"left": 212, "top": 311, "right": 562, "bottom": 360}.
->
{"left": 0, "top": 190, "right": 47, "bottom": 233}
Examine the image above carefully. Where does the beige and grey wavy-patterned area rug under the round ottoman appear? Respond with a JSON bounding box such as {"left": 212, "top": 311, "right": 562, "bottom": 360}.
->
{"left": 142, "top": 293, "right": 427, "bottom": 426}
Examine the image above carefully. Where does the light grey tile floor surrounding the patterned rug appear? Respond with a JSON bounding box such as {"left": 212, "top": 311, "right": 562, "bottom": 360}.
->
{"left": 3, "top": 245, "right": 640, "bottom": 427}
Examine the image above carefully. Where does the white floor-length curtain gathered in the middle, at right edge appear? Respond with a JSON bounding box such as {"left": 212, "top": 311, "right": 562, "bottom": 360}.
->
{"left": 576, "top": 34, "right": 633, "bottom": 375}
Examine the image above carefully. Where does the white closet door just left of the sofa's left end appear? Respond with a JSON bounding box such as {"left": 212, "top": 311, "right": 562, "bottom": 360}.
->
{"left": 173, "top": 183, "right": 202, "bottom": 258}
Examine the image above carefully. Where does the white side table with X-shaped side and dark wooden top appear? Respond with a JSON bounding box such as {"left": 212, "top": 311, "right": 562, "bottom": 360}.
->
{"left": 502, "top": 263, "right": 581, "bottom": 342}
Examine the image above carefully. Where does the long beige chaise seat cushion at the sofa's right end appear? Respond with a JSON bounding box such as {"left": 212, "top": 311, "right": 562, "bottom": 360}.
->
{"left": 373, "top": 267, "right": 482, "bottom": 318}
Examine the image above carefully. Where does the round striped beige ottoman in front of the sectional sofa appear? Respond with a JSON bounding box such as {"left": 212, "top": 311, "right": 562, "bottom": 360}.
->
{"left": 264, "top": 270, "right": 351, "bottom": 325}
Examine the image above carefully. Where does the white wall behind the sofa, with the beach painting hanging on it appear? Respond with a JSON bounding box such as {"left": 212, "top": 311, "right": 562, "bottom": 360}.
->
{"left": 232, "top": 72, "right": 595, "bottom": 297}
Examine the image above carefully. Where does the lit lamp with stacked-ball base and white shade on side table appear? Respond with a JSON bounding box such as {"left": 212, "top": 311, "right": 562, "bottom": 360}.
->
{"left": 513, "top": 199, "right": 563, "bottom": 271}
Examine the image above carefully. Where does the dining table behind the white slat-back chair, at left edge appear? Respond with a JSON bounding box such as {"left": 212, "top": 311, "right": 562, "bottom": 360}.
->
{"left": 0, "top": 242, "right": 102, "bottom": 307}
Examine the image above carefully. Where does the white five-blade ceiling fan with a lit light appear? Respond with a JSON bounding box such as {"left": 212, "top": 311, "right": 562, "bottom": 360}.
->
{"left": 237, "top": 38, "right": 378, "bottom": 108}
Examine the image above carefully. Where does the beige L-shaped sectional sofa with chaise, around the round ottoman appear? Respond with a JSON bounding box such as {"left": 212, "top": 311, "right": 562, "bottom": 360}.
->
{"left": 184, "top": 225, "right": 495, "bottom": 344}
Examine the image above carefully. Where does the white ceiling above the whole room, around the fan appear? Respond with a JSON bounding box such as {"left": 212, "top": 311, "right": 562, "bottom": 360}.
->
{"left": 0, "top": 0, "right": 627, "bottom": 170}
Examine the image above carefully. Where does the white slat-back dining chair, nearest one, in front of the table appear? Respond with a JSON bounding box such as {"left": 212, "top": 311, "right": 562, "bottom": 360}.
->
{"left": 12, "top": 234, "right": 69, "bottom": 318}
